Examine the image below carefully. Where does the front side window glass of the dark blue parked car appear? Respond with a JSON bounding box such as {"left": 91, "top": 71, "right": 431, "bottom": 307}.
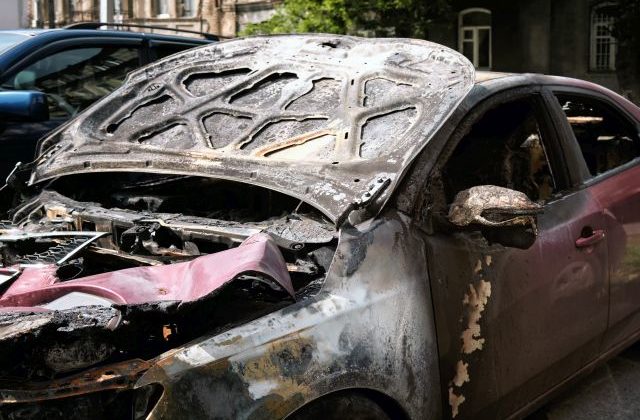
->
{"left": 2, "top": 46, "right": 139, "bottom": 118}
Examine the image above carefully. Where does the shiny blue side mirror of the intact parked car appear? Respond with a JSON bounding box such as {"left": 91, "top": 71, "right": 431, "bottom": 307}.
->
{"left": 0, "top": 90, "right": 49, "bottom": 122}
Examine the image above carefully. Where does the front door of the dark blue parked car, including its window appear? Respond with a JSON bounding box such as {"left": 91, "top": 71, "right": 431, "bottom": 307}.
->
{"left": 0, "top": 39, "right": 140, "bottom": 179}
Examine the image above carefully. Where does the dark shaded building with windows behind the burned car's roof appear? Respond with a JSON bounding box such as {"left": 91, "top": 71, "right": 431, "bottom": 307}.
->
{"left": 429, "top": 0, "right": 640, "bottom": 98}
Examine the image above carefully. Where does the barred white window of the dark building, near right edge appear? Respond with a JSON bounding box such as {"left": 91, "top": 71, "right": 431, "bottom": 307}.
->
{"left": 589, "top": 3, "right": 617, "bottom": 71}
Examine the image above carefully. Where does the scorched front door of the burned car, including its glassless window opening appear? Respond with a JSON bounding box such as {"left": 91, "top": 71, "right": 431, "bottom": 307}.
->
{"left": 427, "top": 89, "right": 608, "bottom": 418}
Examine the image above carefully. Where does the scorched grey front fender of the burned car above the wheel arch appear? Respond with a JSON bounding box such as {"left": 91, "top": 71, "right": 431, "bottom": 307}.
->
{"left": 137, "top": 211, "right": 441, "bottom": 419}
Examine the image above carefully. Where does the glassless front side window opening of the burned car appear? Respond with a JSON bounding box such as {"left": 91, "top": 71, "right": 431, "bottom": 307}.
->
{"left": 442, "top": 99, "right": 556, "bottom": 203}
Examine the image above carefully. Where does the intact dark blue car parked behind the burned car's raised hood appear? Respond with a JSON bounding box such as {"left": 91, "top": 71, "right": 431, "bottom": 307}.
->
{"left": 0, "top": 23, "right": 215, "bottom": 181}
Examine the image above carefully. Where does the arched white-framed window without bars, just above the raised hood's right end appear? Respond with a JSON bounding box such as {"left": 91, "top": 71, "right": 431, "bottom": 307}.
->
{"left": 458, "top": 7, "right": 491, "bottom": 70}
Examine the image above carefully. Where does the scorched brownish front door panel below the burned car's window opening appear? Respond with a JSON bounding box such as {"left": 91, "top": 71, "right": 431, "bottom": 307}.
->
{"left": 428, "top": 191, "right": 608, "bottom": 418}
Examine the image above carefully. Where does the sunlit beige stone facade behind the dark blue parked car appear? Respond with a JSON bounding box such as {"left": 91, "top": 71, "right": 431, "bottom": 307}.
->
{"left": 27, "top": 0, "right": 282, "bottom": 37}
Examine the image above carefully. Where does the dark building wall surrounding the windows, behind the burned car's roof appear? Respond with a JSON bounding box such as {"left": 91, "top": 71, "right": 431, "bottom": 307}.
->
{"left": 429, "top": 0, "right": 624, "bottom": 98}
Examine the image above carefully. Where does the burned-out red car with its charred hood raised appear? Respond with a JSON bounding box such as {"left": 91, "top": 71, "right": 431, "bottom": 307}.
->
{"left": 0, "top": 35, "right": 640, "bottom": 419}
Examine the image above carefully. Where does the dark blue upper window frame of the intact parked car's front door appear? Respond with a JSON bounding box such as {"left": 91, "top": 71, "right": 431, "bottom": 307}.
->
{"left": 0, "top": 37, "right": 146, "bottom": 85}
